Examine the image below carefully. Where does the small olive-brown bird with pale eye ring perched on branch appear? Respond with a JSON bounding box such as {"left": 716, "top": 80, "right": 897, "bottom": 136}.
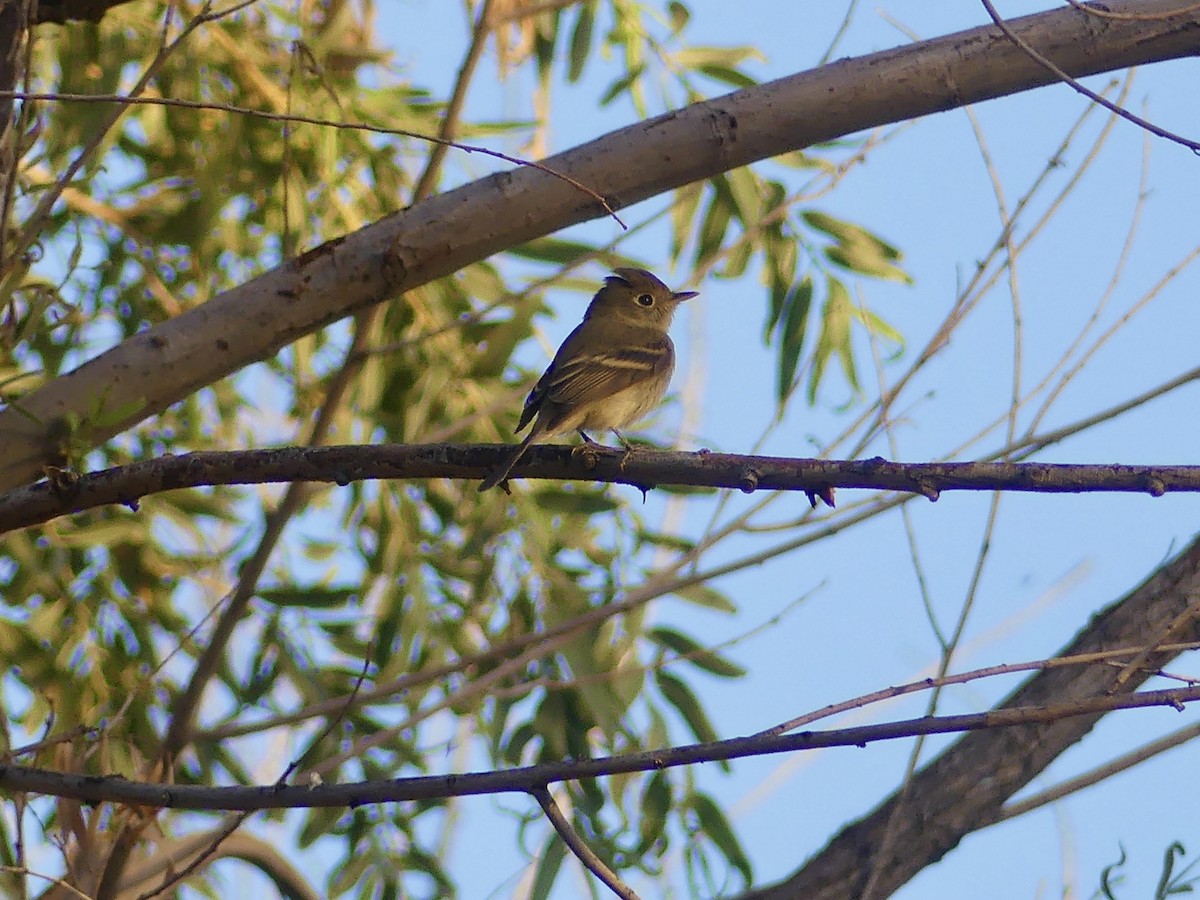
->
{"left": 479, "top": 268, "right": 697, "bottom": 491}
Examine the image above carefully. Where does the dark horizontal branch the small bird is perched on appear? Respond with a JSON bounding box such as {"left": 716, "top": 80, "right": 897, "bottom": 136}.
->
{"left": 0, "top": 444, "right": 1200, "bottom": 533}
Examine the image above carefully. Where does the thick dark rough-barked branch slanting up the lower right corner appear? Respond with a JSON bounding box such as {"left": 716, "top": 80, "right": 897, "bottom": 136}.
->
{"left": 742, "top": 540, "right": 1200, "bottom": 900}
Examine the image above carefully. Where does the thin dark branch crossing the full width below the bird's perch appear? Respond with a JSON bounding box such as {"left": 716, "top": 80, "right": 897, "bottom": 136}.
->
{"left": 0, "top": 685, "right": 1200, "bottom": 812}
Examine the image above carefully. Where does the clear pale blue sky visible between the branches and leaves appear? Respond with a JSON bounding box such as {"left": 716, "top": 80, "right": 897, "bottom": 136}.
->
{"left": 369, "top": 0, "right": 1200, "bottom": 900}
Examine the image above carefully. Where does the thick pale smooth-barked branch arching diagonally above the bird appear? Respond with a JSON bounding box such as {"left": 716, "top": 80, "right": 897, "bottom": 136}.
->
{"left": 0, "top": 0, "right": 1200, "bottom": 490}
